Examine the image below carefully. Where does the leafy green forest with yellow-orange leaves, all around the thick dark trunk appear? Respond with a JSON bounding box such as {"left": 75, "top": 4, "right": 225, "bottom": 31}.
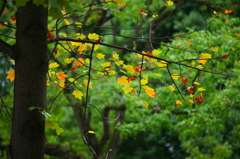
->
{"left": 0, "top": 0, "right": 240, "bottom": 159}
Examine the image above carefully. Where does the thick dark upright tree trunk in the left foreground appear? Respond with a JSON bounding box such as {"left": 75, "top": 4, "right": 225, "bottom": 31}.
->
{"left": 8, "top": 0, "right": 48, "bottom": 159}
